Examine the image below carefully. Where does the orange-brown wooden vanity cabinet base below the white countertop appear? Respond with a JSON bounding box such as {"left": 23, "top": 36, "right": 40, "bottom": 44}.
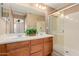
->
{"left": 0, "top": 37, "right": 53, "bottom": 56}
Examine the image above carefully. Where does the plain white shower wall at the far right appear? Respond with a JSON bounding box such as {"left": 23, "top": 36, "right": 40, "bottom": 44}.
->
{"left": 64, "top": 12, "right": 79, "bottom": 56}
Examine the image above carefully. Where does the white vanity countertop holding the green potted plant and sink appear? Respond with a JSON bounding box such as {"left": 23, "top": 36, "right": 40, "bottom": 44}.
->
{"left": 0, "top": 34, "right": 54, "bottom": 44}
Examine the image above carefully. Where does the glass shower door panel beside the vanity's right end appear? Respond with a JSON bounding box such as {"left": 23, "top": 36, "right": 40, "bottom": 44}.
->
{"left": 49, "top": 15, "right": 64, "bottom": 54}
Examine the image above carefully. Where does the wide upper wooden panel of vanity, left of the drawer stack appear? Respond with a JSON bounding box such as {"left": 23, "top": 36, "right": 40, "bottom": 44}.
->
{"left": 6, "top": 41, "right": 30, "bottom": 51}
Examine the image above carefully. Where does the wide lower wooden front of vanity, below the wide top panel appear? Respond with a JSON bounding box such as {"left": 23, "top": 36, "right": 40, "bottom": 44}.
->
{"left": 7, "top": 47, "right": 30, "bottom": 56}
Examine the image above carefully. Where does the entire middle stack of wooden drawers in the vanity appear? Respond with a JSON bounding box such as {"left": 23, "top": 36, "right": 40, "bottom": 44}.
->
{"left": 31, "top": 39, "right": 43, "bottom": 56}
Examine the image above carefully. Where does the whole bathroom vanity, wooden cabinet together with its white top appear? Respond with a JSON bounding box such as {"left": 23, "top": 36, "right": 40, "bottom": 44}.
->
{"left": 0, "top": 35, "right": 53, "bottom": 56}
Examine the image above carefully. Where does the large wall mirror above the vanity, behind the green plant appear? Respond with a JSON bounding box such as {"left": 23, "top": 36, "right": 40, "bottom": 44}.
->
{"left": 0, "top": 3, "right": 46, "bottom": 34}
